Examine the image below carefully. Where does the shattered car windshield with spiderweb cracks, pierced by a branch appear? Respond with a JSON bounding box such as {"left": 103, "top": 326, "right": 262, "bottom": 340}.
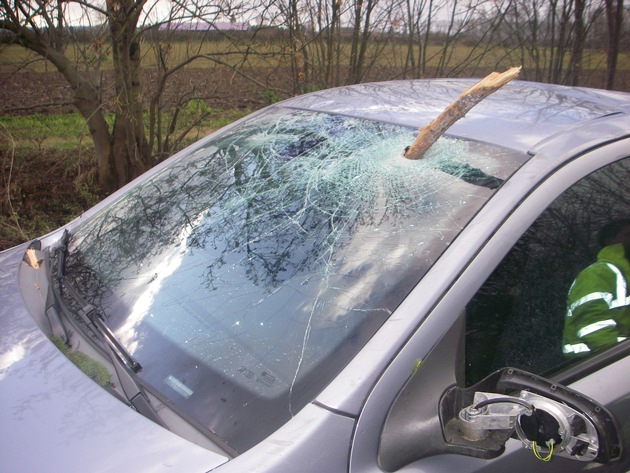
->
{"left": 66, "top": 108, "right": 526, "bottom": 453}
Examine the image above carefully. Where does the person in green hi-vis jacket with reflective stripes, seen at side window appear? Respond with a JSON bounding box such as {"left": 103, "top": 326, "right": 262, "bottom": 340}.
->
{"left": 562, "top": 219, "right": 630, "bottom": 357}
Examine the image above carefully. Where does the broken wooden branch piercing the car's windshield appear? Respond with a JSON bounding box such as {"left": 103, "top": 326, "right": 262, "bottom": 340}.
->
{"left": 405, "top": 66, "right": 521, "bottom": 159}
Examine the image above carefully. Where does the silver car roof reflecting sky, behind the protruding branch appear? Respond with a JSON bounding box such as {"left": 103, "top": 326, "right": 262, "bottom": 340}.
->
{"left": 280, "top": 79, "right": 630, "bottom": 152}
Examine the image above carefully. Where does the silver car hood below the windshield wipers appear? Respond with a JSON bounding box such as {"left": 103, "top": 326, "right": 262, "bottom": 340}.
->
{"left": 0, "top": 245, "right": 227, "bottom": 473}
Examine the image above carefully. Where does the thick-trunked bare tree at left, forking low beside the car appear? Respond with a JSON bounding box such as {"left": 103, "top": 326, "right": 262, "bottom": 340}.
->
{"left": 0, "top": 0, "right": 158, "bottom": 189}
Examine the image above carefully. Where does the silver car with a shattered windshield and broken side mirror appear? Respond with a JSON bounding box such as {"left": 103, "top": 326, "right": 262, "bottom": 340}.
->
{"left": 0, "top": 79, "right": 630, "bottom": 473}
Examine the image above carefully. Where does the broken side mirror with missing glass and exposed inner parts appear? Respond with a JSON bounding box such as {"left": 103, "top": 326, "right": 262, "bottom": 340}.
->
{"left": 379, "top": 368, "right": 621, "bottom": 471}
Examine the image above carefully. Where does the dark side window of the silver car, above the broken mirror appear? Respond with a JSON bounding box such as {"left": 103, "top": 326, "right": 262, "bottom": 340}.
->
{"left": 466, "top": 158, "right": 630, "bottom": 385}
